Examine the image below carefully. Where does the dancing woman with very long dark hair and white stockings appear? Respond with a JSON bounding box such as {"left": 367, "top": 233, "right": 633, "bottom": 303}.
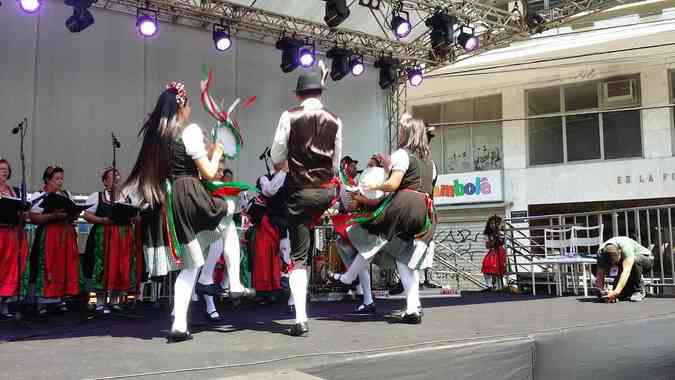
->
{"left": 125, "top": 82, "right": 251, "bottom": 343}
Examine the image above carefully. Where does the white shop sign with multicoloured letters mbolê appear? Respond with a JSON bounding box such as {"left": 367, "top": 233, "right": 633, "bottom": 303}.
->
{"left": 434, "top": 170, "right": 504, "bottom": 206}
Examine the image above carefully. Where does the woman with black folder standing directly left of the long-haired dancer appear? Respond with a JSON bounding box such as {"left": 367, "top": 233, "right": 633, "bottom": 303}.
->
{"left": 82, "top": 168, "right": 140, "bottom": 314}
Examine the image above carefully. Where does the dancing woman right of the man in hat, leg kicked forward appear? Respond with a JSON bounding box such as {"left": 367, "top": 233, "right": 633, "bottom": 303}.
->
{"left": 332, "top": 114, "right": 435, "bottom": 324}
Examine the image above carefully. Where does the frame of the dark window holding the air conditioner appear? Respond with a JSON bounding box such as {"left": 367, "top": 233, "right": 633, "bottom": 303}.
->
{"left": 524, "top": 75, "right": 644, "bottom": 167}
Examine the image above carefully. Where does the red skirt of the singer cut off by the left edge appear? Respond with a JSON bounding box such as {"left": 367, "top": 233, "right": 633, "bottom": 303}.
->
{"left": 0, "top": 226, "right": 28, "bottom": 297}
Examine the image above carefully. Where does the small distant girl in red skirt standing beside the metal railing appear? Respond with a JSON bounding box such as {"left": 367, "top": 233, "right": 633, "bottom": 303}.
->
{"left": 481, "top": 215, "right": 506, "bottom": 291}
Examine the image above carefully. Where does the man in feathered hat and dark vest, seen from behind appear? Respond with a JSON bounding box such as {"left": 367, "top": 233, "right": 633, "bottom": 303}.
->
{"left": 271, "top": 62, "right": 342, "bottom": 336}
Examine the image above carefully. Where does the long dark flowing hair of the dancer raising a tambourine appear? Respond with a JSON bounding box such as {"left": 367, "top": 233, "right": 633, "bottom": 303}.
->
{"left": 122, "top": 88, "right": 187, "bottom": 206}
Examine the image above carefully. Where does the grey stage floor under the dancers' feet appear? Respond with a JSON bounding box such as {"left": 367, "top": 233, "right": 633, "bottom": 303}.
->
{"left": 0, "top": 293, "right": 675, "bottom": 380}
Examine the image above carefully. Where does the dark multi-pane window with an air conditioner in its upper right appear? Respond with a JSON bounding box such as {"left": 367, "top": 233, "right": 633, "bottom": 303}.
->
{"left": 526, "top": 76, "right": 644, "bottom": 165}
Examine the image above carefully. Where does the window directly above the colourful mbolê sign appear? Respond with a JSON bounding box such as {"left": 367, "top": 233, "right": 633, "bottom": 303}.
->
{"left": 413, "top": 95, "right": 502, "bottom": 174}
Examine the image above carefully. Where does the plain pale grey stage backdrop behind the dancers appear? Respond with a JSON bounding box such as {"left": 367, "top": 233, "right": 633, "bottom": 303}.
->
{"left": 0, "top": 1, "right": 388, "bottom": 193}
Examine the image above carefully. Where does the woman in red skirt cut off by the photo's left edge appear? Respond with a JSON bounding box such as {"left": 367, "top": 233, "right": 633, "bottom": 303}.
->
{"left": 0, "top": 158, "right": 28, "bottom": 319}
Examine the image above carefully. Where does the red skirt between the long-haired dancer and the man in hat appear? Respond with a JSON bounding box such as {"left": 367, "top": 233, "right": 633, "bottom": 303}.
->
{"left": 251, "top": 215, "right": 281, "bottom": 292}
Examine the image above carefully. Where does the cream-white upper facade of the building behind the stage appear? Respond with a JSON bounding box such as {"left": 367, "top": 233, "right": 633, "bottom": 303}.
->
{"left": 407, "top": 22, "right": 675, "bottom": 212}
